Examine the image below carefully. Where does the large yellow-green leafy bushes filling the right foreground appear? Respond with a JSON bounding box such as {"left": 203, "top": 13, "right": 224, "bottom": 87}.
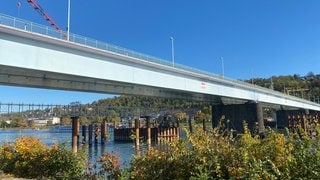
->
{"left": 129, "top": 122, "right": 320, "bottom": 179}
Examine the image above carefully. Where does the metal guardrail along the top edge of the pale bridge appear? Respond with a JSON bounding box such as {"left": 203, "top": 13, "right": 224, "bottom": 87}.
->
{"left": 0, "top": 13, "right": 319, "bottom": 103}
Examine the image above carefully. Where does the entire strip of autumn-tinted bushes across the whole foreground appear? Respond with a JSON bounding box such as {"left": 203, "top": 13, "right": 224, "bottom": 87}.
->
{"left": 0, "top": 121, "right": 320, "bottom": 180}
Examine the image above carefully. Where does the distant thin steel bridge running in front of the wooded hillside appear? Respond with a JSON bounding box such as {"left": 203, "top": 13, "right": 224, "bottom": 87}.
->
{"left": 0, "top": 103, "right": 199, "bottom": 119}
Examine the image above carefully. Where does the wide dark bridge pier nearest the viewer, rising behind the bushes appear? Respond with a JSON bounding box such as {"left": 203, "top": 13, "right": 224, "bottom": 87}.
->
{"left": 212, "top": 103, "right": 265, "bottom": 135}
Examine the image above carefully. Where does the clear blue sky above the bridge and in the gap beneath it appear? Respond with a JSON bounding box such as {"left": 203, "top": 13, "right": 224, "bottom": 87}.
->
{"left": 0, "top": 0, "right": 320, "bottom": 104}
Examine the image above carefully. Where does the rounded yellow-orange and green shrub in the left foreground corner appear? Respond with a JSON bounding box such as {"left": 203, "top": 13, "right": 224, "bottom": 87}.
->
{"left": 0, "top": 136, "right": 86, "bottom": 179}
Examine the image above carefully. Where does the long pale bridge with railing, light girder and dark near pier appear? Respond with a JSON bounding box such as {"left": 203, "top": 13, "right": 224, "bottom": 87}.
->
{"left": 0, "top": 14, "right": 320, "bottom": 134}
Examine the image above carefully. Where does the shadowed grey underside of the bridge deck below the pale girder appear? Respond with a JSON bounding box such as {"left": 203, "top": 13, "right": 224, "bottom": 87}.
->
{"left": 0, "top": 66, "right": 225, "bottom": 104}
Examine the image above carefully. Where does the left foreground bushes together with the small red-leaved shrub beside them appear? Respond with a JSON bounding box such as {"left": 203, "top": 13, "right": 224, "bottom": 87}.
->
{"left": 0, "top": 136, "right": 120, "bottom": 179}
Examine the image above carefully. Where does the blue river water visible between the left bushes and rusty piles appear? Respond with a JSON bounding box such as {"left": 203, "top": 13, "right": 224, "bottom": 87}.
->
{"left": 0, "top": 129, "right": 135, "bottom": 166}
